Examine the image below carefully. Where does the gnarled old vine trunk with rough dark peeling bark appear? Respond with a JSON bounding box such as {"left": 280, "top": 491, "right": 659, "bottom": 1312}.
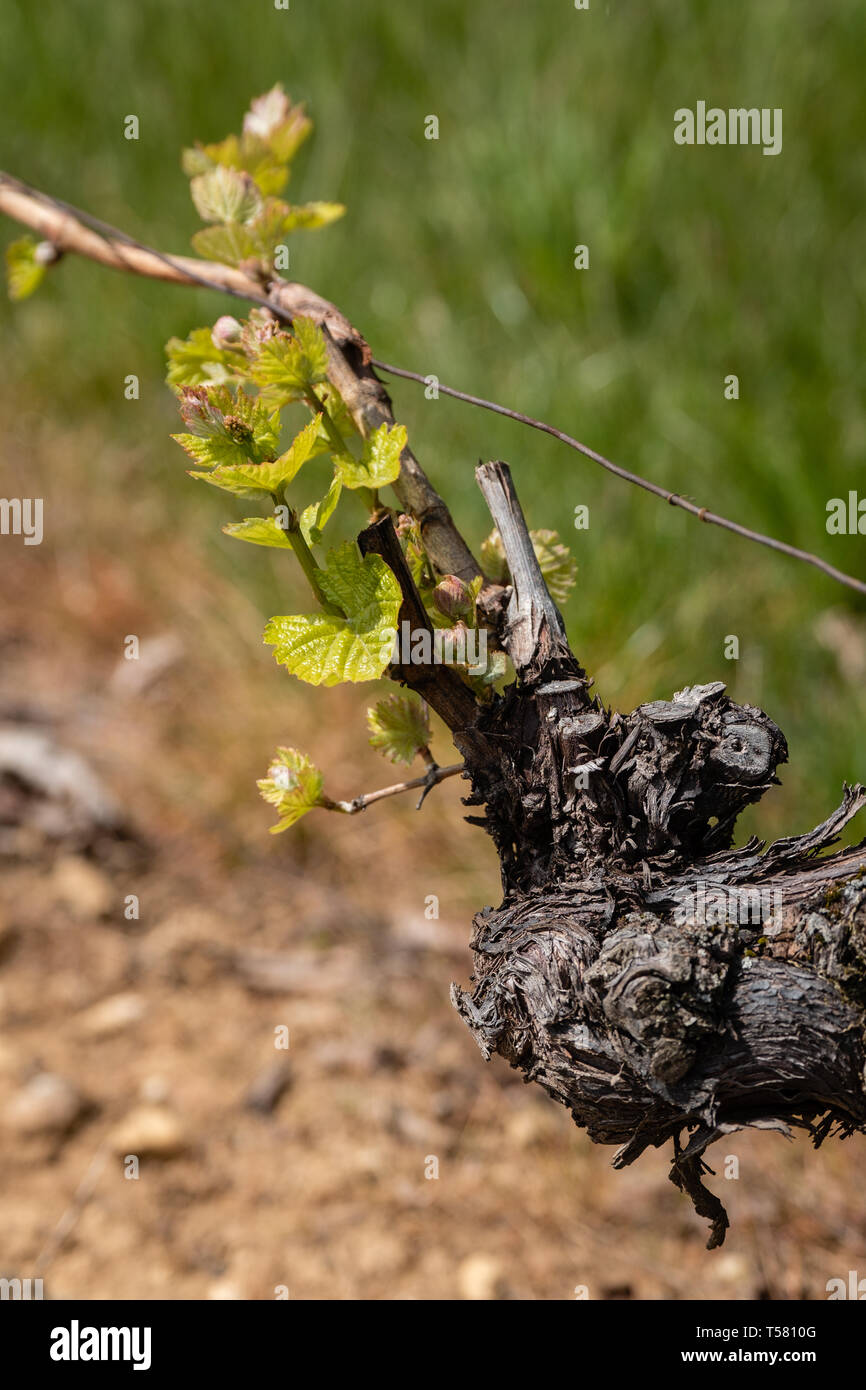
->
{"left": 439, "top": 463, "right": 866, "bottom": 1248}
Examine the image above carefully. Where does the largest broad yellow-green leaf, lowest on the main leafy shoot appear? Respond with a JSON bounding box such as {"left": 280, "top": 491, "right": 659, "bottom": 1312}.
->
{"left": 264, "top": 541, "right": 402, "bottom": 685}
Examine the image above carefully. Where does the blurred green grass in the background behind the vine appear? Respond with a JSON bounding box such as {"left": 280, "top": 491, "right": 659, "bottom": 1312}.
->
{"left": 0, "top": 0, "right": 866, "bottom": 834}
